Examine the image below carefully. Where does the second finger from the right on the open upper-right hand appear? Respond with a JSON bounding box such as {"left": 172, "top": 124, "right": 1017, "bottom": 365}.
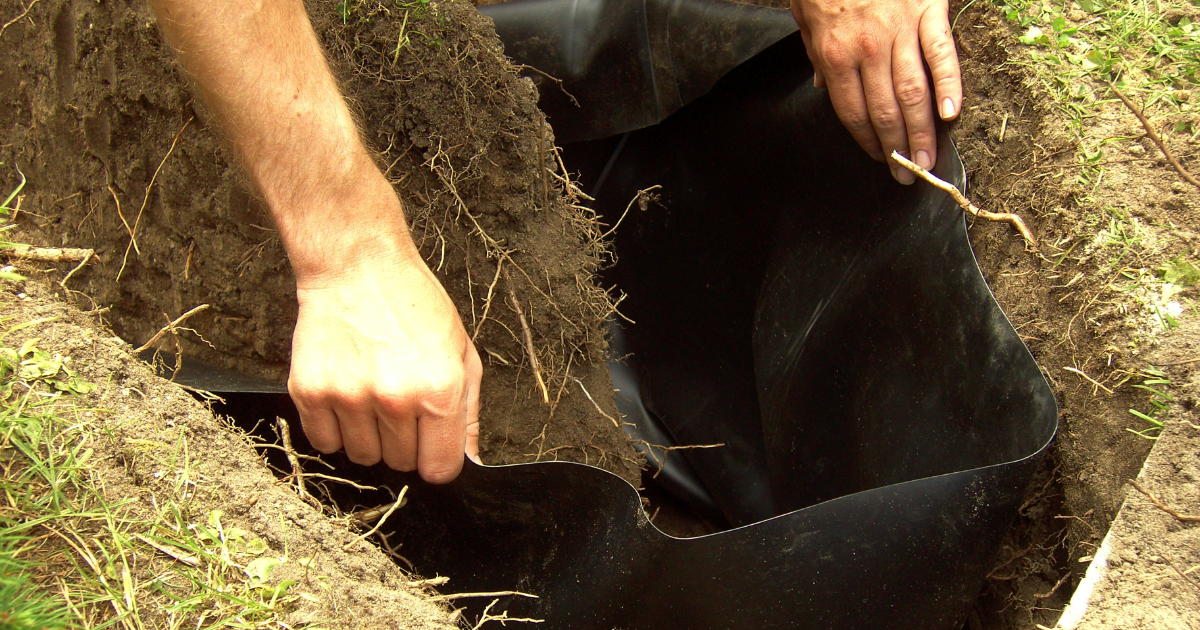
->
{"left": 892, "top": 31, "right": 937, "bottom": 170}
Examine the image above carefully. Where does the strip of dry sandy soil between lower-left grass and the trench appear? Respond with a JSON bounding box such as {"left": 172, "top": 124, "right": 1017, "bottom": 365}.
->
{"left": 0, "top": 276, "right": 458, "bottom": 630}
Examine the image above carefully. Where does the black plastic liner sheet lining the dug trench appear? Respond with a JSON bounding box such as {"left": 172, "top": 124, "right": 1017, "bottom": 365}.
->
{"left": 177, "top": 0, "right": 1057, "bottom": 630}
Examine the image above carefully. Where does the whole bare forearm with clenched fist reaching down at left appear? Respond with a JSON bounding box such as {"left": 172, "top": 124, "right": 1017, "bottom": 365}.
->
{"left": 151, "top": 0, "right": 482, "bottom": 482}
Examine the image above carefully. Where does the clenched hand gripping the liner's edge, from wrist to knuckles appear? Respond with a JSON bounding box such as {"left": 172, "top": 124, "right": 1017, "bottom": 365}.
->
{"left": 288, "top": 241, "right": 482, "bottom": 484}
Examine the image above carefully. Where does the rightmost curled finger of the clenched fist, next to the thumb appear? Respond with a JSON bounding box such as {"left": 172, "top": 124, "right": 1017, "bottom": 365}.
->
{"left": 416, "top": 374, "right": 467, "bottom": 484}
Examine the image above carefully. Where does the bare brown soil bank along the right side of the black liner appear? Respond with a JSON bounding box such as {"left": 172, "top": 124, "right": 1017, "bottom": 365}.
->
{"left": 950, "top": 2, "right": 1200, "bottom": 629}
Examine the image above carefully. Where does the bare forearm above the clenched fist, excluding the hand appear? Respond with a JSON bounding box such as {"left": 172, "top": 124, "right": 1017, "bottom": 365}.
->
{"left": 150, "top": 0, "right": 412, "bottom": 282}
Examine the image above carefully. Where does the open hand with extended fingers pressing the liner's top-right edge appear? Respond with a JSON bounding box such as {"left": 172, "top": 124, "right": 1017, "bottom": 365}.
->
{"left": 792, "top": 0, "right": 962, "bottom": 184}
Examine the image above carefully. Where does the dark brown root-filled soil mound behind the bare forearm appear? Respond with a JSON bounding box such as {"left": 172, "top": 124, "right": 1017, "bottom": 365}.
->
{"left": 0, "top": 0, "right": 640, "bottom": 485}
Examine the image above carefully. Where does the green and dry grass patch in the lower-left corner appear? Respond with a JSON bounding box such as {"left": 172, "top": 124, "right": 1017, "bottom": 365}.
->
{"left": 0, "top": 178, "right": 312, "bottom": 630}
